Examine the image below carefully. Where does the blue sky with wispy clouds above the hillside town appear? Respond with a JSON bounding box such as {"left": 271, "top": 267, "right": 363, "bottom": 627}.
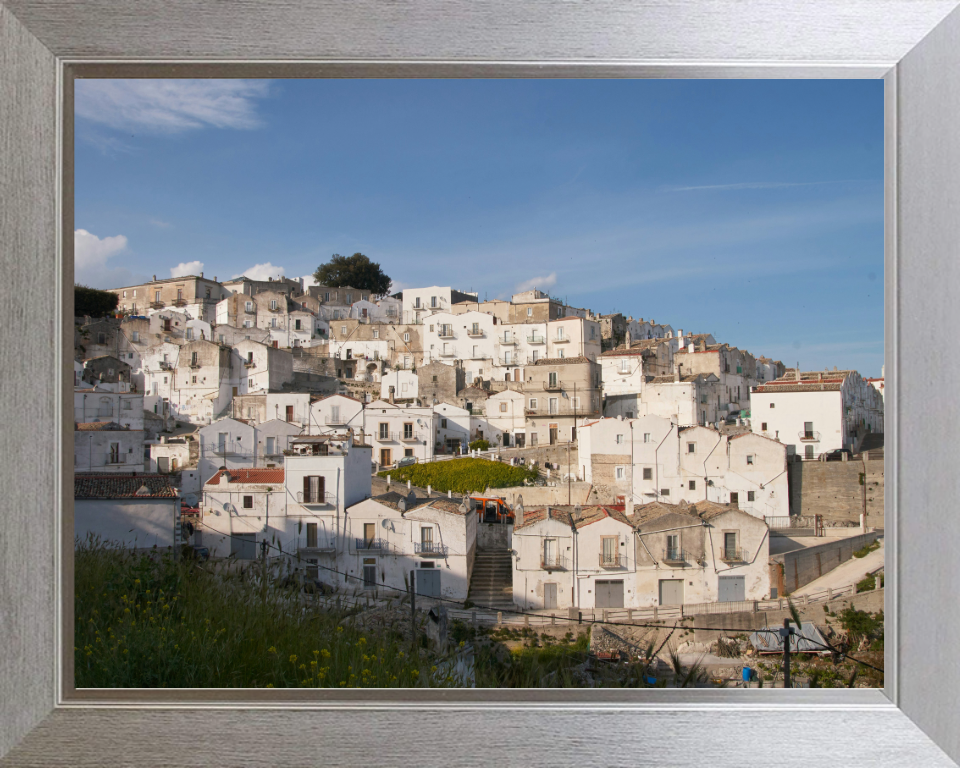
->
{"left": 75, "top": 80, "right": 883, "bottom": 376}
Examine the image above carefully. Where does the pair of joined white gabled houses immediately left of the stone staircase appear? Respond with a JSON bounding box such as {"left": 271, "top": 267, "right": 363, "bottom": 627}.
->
{"left": 340, "top": 492, "right": 477, "bottom": 600}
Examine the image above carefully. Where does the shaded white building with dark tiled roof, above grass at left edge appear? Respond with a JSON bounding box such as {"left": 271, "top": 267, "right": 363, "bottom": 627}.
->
{"left": 73, "top": 472, "right": 180, "bottom": 549}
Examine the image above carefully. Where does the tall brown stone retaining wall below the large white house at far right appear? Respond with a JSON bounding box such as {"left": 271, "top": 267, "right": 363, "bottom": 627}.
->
{"left": 787, "top": 459, "right": 884, "bottom": 528}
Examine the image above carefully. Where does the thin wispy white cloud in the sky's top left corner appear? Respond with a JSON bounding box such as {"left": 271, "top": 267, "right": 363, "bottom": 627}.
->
{"left": 74, "top": 80, "right": 270, "bottom": 134}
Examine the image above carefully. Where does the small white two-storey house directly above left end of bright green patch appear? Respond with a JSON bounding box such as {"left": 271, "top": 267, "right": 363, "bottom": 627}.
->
{"left": 363, "top": 400, "right": 437, "bottom": 466}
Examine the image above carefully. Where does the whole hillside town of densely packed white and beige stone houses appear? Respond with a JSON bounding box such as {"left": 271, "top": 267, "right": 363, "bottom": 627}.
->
{"left": 73, "top": 273, "right": 884, "bottom": 684}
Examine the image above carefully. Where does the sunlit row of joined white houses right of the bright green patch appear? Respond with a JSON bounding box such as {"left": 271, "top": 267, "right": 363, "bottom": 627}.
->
{"left": 578, "top": 416, "right": 790, "bottom": 517}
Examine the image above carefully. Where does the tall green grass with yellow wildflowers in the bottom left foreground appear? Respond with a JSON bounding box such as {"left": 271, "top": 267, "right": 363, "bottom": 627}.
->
{"left": 74, "top": 541, "right": 451, "bottom": 688}
